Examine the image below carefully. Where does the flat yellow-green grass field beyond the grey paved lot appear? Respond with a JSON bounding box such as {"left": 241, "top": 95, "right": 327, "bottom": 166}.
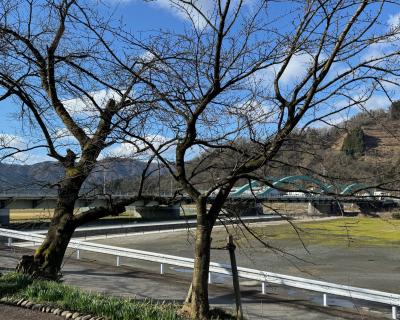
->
{"left": 234, "top": 217, "right": 400, "bottom": 247}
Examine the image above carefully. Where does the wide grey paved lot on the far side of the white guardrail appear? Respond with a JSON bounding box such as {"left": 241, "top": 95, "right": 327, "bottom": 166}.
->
{"left": 90, "top": 221, "right": 400, "bottom": 293}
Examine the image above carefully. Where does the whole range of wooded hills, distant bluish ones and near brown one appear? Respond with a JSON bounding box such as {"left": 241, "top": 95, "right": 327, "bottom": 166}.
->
{"left": 0, "top": 105, "right": 400, "bottom": 192}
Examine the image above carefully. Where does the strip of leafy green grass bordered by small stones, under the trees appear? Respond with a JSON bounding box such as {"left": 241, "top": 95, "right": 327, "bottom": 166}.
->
{"left": 0, "top": 273, "right": 234, "bottom": 320}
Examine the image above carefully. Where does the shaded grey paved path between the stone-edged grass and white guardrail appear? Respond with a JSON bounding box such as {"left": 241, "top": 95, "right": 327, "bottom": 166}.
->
{"left": 0, "top": 247, "right": 390, "bottom": 320}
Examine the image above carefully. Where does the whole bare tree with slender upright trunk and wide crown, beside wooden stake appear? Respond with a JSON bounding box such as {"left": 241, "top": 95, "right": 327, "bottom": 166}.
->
{"left": 116, "top": 0, "right": 398, "bottom": 319}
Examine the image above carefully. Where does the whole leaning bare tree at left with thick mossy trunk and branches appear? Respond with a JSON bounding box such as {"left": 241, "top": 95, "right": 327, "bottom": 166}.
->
{"left": 0, "top": 0, "right": 159, "bottom": 279}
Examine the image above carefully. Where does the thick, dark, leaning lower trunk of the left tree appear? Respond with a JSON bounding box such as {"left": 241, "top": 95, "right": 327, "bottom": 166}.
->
{"left": 16, "top": 181, "right": 81, "bottom": 280}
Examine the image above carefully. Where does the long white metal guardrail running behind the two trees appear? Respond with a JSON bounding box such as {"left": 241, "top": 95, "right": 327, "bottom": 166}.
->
{"left": 0, "top": 228, "right": 400, "bottom": 319}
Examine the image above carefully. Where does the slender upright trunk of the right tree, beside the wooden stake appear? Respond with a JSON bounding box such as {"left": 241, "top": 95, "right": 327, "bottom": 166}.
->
{"left": 183, "top": 200, "right": 212, "bottom": 320}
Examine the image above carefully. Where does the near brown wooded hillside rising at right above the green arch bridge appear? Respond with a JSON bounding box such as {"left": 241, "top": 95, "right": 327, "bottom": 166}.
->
{"left": 180, "top": 105, "right": 400, "bottom": 189}
